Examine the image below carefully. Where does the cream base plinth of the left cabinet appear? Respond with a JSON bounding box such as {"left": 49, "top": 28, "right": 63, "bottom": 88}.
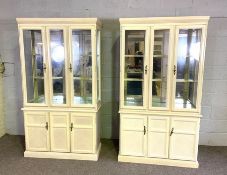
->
{"left": 24, "top": 144, "right": 101, "bottom": 161}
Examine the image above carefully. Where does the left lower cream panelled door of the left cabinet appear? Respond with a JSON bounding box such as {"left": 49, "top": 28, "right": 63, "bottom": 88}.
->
{"left": 24, "top": 112, "right": 50, "bottom": 151}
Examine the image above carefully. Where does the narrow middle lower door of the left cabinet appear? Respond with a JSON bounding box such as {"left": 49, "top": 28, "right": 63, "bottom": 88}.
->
{"left": 50, "top": 112, "right": 70, "bottom": 152}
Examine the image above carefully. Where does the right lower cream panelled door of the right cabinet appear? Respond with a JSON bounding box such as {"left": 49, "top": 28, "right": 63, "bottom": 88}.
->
{"left": 169, "top": 118, "right": 199, "bottom": 161}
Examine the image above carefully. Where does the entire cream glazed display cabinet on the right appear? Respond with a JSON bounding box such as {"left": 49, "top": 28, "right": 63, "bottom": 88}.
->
{"left": 118, "top": 16, "right": 209, "bottom": 168}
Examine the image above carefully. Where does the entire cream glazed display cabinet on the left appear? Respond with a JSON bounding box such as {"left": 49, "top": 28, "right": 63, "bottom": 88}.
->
{"left": 17, "top": 18, "right": 101, "bottom": 160}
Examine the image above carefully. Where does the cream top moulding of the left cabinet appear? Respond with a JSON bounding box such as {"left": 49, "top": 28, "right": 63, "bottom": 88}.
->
{"left": 16, "top": 18, "right": 101, "bottom": 26}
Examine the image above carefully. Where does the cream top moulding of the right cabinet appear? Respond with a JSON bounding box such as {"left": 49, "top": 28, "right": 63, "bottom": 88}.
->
{"left": 119, "top": 16, "right": 210, "bottom": 25}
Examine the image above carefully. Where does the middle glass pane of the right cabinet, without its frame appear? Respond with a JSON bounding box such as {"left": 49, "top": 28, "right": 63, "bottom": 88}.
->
{"left": 151, "top": 29, "right": 170, "bottom": 107}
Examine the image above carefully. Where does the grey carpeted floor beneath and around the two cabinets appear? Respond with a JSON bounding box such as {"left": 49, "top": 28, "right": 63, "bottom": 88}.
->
{"left": 0, "top": 135, "right": 227, "bottom": 175}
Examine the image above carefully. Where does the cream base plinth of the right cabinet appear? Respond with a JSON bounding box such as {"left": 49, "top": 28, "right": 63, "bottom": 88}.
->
{"left": 118, "top": 155, "right": 199, "bottom": 168}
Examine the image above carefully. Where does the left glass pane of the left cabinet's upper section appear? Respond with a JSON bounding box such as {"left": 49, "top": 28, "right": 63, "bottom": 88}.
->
{"left": 23, "top": 30, "right": 46, "bottom": 103}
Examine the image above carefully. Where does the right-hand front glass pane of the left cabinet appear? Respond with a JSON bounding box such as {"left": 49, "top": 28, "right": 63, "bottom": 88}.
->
{"left": 72, "top": 30, "right": 92, "bottom": 104}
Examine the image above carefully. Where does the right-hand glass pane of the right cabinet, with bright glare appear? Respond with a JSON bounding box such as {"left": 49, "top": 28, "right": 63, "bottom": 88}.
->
{"left": 175, "top": 29, "right": 202, "bottom": 109}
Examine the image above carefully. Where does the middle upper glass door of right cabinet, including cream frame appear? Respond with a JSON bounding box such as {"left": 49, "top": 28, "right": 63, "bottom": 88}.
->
{"left": 149, "top": 27, "right": 173, "bottom": 110}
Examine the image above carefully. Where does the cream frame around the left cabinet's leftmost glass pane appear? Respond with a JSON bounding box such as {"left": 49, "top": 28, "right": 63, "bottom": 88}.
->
{"left": 18, "top": 25, "right": 49, "bottom": 106}
